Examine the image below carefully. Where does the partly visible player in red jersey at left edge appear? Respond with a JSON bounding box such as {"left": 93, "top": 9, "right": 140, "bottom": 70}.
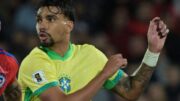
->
{"left": 0, "top": 22, "right": 21, "bottom": 101}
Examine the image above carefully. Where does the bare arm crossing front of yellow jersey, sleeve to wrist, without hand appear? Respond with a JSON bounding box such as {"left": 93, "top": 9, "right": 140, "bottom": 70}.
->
{"left": 40, "top": 73, "right": 106, "bottom": 101}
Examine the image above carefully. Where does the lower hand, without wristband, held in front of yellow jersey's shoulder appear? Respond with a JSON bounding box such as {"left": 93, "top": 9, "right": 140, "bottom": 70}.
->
{"left": 103, "top": 54, "right": 127, "bottom": 78}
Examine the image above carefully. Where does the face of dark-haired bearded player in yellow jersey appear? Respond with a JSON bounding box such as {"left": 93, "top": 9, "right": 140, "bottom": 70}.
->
{"left": 36, "top": 6, "right": 70, "bottom": 47}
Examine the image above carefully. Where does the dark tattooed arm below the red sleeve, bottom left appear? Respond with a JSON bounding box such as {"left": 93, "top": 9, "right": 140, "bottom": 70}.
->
{"left": 4, "top": 80, "right": 22, "bottom": 101}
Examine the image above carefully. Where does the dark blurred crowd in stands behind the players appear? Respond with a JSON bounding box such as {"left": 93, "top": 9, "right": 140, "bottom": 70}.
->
{"left": 0, "top": 0, "right": 180, "bottom": 101}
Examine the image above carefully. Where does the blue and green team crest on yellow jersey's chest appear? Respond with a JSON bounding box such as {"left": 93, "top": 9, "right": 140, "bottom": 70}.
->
{"left": 59, "top": 76, "right": 71, "bottom": 93}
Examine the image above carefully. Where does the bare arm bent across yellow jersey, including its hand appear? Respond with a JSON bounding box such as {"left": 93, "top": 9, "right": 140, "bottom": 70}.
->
{"left": 39, "top": 54, "right": 127, "bottom": 101}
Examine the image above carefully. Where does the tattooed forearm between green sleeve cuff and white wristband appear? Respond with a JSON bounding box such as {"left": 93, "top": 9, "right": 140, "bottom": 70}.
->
{"left": 114, "top": 63, "right": 154, "bottom": 101}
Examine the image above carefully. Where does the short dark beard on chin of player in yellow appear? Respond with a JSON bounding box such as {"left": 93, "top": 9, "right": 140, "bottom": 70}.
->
{"left": 40, "top": 34, "right": 55, "bottom": 47}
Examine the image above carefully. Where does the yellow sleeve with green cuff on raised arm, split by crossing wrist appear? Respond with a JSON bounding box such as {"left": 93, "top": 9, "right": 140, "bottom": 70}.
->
{"left": 89, "top": 47, "right": 126, "bottom": 90}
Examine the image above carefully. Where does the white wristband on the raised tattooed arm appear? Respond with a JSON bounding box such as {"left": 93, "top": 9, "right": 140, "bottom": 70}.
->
{"left": 143, "top": 49, "right": 160, "bottom": 67}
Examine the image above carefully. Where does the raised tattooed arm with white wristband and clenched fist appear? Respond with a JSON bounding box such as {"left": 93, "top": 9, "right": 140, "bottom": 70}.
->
{"left": 113, "top": 17, "right": 169, "bottom": 101}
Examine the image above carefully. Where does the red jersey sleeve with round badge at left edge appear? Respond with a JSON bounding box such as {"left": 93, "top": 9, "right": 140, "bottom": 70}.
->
{"left": 0, "top": 51, "right": 19, "bottom": 95}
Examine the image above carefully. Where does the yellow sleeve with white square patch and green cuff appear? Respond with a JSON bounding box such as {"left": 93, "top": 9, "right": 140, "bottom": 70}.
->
{"left": 18, "top": 57, "right": 59, "bottom": 98}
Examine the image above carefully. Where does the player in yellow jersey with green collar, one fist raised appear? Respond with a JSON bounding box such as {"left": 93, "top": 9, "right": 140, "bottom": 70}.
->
{"left": 18, "top": 0, "right": 169, "bottom": 101}
